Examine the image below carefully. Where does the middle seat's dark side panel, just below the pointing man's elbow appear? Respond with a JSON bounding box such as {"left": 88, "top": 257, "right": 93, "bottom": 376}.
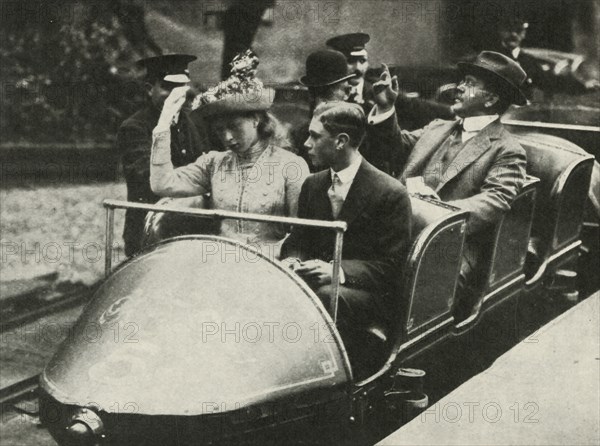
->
{"left": 483, "top": 176, "right": 540, "bottom": 303}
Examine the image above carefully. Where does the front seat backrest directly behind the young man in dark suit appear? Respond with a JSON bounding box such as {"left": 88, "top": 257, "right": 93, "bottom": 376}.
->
{"left": 400, "top": 196, "right": 468, "bottom": 342}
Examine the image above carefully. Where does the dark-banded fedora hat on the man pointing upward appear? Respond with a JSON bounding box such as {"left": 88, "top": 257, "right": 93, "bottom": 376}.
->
{"left": 458, "top": 51, "right": 527, "bottom": 105}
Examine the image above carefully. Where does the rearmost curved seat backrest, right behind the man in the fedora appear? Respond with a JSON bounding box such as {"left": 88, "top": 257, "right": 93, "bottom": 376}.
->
{"left": 514, "top": 133, "right": 594, "bottom": 261}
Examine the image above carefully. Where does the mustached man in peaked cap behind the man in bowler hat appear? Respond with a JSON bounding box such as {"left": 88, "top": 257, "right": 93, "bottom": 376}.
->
{"left": 325, "top": 33, "right": 374, "bottom": 113}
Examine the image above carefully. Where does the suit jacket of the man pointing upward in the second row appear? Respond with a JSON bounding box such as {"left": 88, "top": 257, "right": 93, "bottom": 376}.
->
{"left": 369, "top": 116, "right": 527, "bottom": 234}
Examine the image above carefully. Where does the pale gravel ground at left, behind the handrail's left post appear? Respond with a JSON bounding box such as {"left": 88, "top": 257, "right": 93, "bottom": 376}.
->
{"left": 0, "top": 183, "right": 127, "bottom": 284}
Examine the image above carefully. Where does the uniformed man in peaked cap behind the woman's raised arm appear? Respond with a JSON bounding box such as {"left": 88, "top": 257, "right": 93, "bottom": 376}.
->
{"left": 117, "top": 54, "right": 207, "bottom": 256}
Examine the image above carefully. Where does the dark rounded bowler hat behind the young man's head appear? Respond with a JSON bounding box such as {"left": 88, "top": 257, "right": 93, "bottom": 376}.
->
{"left": 300, "top": 50, "right": 356, "bottom": 87}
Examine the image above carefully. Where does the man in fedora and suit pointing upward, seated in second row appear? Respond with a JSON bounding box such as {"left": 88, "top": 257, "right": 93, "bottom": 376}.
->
{"left": 369, "top": 51, "right": 527, "bottom": 317}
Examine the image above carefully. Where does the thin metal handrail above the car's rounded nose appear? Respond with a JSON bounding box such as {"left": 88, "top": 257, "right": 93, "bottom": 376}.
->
{"left": 103, "top": 199, "right": 348, "bottom": 323}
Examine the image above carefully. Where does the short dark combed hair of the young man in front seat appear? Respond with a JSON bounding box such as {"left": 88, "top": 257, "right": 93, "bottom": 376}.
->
{"left": 314, "top": 101, "right": 367, "bottom": 147}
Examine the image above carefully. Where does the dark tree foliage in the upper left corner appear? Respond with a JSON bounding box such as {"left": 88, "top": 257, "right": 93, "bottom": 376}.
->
{"left": 0, "top": 1, "right": 155, "bottom": 143}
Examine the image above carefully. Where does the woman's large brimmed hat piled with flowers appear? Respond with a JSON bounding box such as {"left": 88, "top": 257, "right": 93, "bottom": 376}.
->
{"left": 192, "top": 50, "right": 274, "bottom": 117}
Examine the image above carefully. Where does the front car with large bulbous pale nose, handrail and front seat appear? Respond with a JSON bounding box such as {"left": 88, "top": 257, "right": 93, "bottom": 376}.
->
{"left": 40, "top": 197, "right": 467, "bottom": 445}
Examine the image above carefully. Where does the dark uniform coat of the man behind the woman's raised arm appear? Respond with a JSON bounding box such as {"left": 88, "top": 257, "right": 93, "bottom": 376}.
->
{"left": 117, "top": 105, "right": 209, "bottom": 256}
